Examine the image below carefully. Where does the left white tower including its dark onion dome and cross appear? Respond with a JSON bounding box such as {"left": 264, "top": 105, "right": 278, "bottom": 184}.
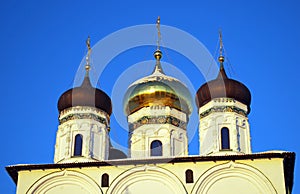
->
{"left": 54, "top": 39, "right": 112, "bottom": 163}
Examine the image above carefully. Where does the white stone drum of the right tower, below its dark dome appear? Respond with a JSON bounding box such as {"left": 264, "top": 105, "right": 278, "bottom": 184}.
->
{"left": 199, "top": 98, "right": 251, "bottom": 155}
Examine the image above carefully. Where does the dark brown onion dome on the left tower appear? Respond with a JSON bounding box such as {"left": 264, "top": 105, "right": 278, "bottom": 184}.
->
{"left": 57, "top": 73, "right": 112, "bottom": 115}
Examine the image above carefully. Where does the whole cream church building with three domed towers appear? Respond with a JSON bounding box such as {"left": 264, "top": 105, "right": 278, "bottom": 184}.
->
{"left": 6, "top": 20, "right": 295, "bottom": 194}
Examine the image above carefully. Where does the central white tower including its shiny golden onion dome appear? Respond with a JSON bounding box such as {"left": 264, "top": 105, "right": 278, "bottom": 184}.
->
{"left": 124, "top": 50, "right": 192, "bottom": 158}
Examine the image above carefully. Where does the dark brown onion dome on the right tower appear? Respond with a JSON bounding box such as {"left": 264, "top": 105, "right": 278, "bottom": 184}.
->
{"left": 196, "top": 63, "right": 251, "bottom": 114}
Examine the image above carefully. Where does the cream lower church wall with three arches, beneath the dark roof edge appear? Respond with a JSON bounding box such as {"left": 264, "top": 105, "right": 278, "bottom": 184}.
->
{"left": 16, "top": 152, "right": 291, "bottom": 194}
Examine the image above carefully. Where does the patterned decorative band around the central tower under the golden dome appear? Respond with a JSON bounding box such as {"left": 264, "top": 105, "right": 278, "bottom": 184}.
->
{"left": 129, "top": 116, "right": 187, "bottom": 132}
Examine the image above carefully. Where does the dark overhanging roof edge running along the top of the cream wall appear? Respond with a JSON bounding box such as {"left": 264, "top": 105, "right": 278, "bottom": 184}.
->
{"left": 5, "top": 152, "right": 295, "bottom": 185}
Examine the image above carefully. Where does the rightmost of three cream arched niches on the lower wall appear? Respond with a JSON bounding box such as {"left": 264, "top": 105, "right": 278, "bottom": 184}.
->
{"left": 192, "top": 161, "right": 277, "bottom": 194}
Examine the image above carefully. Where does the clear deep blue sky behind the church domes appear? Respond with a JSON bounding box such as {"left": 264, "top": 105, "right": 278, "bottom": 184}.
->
{"left": 0, "top": 0, "right": 300, "bottom": 194}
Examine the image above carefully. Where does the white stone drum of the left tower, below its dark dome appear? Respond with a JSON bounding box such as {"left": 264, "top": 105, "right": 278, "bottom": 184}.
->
{"left": 54, "top": 106, "right": 109, "bottom": 163}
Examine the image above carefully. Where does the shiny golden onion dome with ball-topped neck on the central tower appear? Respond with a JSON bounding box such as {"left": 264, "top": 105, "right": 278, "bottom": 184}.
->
{"left": 123, "top": 50, "right": 192, "bottom": 116}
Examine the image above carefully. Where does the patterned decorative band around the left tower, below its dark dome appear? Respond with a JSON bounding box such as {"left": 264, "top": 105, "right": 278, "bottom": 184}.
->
{"left": 59, "top": 113, "right": 108, "bottom": 126}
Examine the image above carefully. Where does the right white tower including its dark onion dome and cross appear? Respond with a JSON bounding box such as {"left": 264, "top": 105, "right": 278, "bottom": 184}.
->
{"left": 196, "top": 34, "right": 251, "bottom": 155}
